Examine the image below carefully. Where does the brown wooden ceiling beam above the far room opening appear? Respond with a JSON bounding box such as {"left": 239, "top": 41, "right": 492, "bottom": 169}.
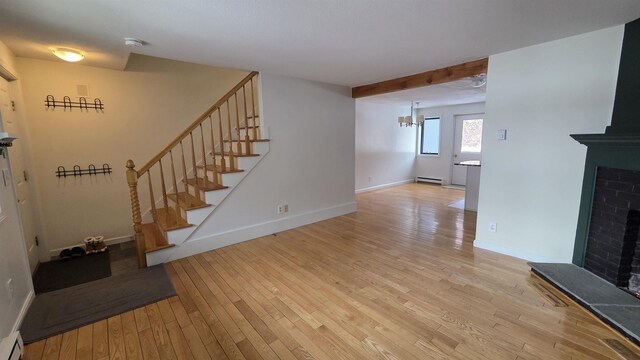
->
{"left": 351, "top": 58, "right": 489, "bottom": 99}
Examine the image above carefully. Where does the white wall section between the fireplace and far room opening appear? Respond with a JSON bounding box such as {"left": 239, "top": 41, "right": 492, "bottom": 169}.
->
{"left": 475, "top": 26, "right": 624, "bottom": 262}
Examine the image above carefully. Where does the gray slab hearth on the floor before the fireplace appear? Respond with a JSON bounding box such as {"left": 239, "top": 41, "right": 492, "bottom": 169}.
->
{"left": 529, "top": 263, "right": 640, "bottom": 345}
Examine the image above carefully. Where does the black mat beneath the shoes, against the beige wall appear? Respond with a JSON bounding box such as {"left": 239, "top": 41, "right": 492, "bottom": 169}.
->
{"left": 33, "top": 251, "right": 111, "bottom": 294}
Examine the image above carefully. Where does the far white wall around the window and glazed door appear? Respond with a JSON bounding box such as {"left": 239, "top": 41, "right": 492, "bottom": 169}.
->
{"left": 416, "top": 102, "right": 485, "bottom": 185}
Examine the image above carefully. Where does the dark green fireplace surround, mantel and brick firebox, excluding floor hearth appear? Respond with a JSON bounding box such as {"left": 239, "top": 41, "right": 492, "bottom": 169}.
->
{"left": 571, "top": 19, "right": 640, "bottom": 293}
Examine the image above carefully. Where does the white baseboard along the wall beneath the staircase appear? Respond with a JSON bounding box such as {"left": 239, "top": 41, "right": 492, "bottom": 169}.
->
{"left": 147, "top": 202, "right": 356, "bottom": 266}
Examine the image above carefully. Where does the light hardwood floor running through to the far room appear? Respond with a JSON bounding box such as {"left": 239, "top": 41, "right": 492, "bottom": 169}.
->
{"left": 26, "top": 184, "right": 640, "bottom": 360}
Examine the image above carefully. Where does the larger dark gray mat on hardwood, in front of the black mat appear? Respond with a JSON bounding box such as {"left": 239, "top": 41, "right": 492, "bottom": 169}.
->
{"left": 20, "top": 264, "right": 176, "bottom": 344}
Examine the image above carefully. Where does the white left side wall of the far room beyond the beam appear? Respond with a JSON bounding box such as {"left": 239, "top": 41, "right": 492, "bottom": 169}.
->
{"left": 356, "top": 99, "right": 416, "bottom": 191}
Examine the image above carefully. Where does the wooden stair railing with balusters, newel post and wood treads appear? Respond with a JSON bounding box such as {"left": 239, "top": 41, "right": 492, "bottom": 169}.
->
{"left": 126, "top": 71, "right": 258, "bottom": 267}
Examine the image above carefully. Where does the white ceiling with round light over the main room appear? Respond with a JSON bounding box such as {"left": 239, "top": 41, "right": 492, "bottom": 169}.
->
{"left": 0, "top": 0, "right": 640, "bottom": 86}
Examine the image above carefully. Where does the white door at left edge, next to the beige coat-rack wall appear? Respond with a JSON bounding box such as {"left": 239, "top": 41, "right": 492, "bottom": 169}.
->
{"left": 0, "top": 78, "right": 38, "bottom": 273}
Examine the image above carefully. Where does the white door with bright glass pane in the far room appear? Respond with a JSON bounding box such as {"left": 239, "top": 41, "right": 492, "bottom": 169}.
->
{"left": 451, "top": 114, "right": 484, "bottom": 186}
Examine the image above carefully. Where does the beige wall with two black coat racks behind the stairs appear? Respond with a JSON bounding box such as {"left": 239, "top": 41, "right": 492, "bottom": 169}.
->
{"left": 17, "top": 54, "right": 247, "bottom": 253}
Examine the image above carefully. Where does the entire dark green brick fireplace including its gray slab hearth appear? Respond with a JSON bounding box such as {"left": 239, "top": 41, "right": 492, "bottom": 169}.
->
{"left": 529, "top": 19, "right": 640, "bottom": 346}
